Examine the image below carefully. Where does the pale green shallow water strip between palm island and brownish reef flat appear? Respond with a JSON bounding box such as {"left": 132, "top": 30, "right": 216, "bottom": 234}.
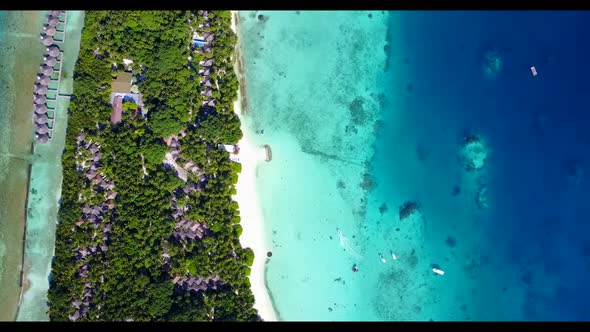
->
{"left": 17, "top": 11, "right": 84, "bottom": 321}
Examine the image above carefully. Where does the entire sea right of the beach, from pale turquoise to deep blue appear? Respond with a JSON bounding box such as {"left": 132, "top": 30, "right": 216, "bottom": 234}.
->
{"left": 240, "top": 12, "right": 590, "bottom": 321}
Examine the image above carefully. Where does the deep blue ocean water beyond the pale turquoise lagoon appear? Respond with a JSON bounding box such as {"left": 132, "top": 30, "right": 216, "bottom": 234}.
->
{"left": 372, "top": 11, "right": 590, "bottom": 320}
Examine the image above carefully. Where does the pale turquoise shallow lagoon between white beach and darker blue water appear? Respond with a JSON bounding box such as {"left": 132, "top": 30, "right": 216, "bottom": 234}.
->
{"left": 240, "top": 12, "right": 388, "bottom": 320}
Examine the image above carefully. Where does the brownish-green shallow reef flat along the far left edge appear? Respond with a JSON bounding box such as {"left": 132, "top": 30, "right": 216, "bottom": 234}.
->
{"left": 0, "top": 11, "right": 44, "bottom": 321}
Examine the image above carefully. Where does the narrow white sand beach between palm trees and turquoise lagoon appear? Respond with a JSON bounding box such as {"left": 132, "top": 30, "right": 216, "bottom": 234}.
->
{"left": 231, "top": 11, "right": 278, "bottom": 321}
